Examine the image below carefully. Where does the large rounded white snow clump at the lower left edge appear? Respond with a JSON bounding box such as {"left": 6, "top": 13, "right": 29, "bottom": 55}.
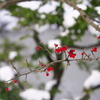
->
{"left": 0, "top": 66, "right": 14, "bottom": 81}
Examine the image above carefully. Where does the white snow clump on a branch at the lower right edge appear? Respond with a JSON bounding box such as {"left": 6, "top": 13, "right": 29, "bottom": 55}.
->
{"left": 84, "top": 70, "right": 100, "bottom": 89}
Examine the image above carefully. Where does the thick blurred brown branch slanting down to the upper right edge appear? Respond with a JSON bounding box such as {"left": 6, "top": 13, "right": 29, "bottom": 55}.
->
{"left": 60, "top": 0, "right": 100, "bottom": 31}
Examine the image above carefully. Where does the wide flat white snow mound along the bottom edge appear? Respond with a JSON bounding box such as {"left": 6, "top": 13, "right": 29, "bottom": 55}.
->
{"left": 20, "top": 89, "right": 50, "bottom": 100}
